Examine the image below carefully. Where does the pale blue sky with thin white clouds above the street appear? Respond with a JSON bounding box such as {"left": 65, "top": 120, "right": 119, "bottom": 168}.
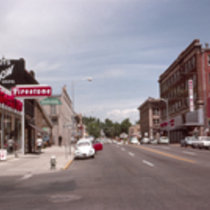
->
{"left": 0, "top": 0, "right": 210, "bottom": 123}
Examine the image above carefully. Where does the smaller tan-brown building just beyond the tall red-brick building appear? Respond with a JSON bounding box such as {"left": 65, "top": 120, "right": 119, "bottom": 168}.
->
{"left": 138, "top": 97, "right": 160, "bottom": 139}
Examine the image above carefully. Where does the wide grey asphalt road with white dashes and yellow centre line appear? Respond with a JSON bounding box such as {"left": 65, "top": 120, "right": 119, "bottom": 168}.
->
{"left": 0, "top": 145, "right": 210, "bottom": 210}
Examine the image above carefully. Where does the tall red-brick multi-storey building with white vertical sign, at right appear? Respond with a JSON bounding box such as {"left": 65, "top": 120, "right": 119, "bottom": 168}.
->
{"left": 159, "top": 39, "right": 210, "bottom": 143}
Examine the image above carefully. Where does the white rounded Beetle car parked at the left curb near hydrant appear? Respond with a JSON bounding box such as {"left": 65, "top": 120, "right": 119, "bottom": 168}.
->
{"left": 74, "top": 139, "right": 95, "bottom": 159}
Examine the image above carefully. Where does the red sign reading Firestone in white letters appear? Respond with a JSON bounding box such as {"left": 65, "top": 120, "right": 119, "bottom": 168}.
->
{"left": 12, "top": 85, "right": 52, "bottom": 98}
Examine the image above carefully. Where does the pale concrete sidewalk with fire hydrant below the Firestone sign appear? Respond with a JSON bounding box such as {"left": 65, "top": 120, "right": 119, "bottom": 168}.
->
{"left": 0, "top": 145, "right": 74, "bottom": 176}
